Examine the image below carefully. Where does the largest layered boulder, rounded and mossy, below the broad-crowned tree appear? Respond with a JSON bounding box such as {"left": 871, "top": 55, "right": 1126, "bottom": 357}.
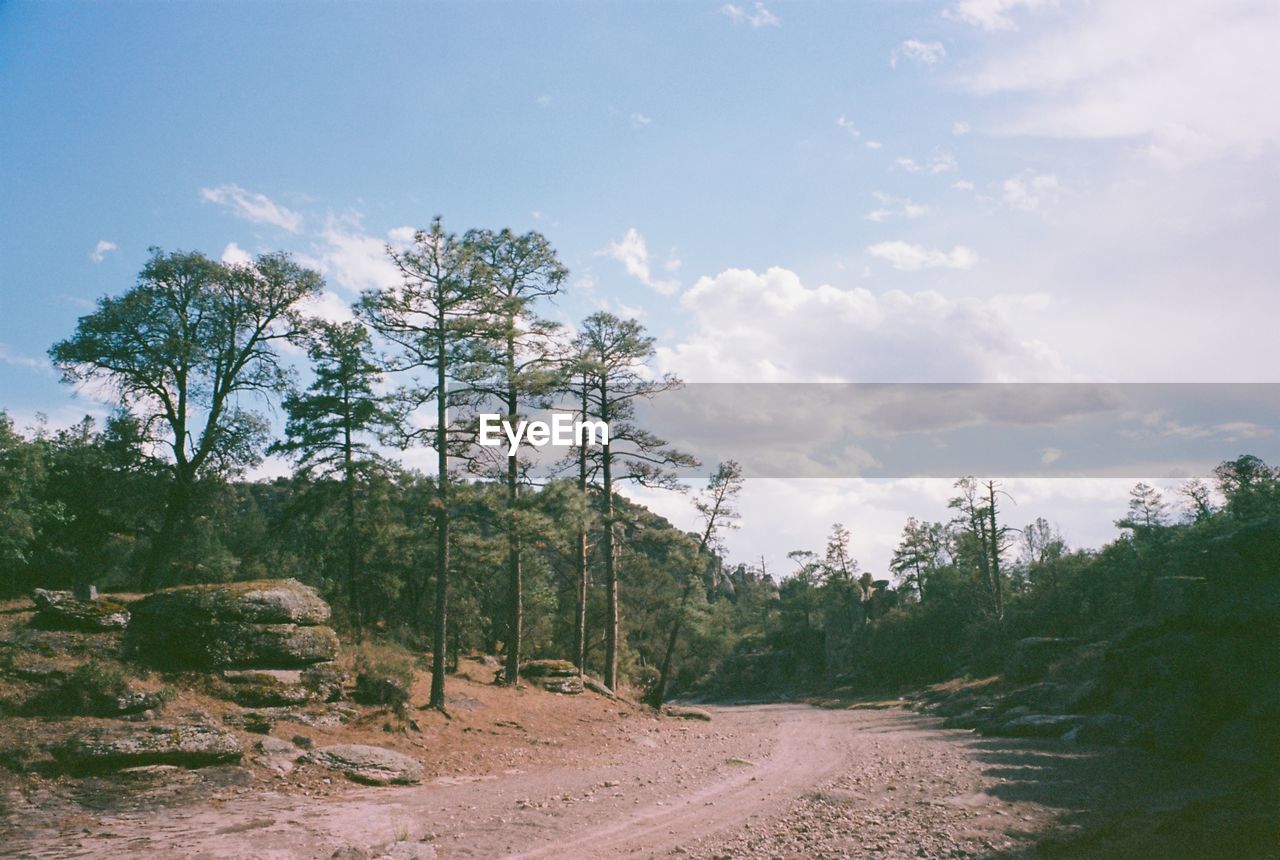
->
{"left": 129, "top": 580, "right": 338, "bottom": 669}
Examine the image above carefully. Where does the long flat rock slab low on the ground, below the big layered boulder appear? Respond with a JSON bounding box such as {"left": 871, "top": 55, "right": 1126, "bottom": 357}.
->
{"left": 52, "top": 723, "right": 242, "bottom": 772}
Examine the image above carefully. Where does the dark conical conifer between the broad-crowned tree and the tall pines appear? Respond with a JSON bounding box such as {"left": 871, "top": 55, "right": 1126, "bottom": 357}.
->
{"left": 271, "top": 320, "right": 394, "bottom": 630}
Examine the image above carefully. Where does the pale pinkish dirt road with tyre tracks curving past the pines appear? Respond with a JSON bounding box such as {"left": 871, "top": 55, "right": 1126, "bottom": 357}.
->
{"left": 0, "top": 705, "right": 1244, "bottom": 859}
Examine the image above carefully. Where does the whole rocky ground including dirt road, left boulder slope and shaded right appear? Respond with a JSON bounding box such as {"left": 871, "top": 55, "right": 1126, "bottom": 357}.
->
{"left": 0, "top": 582, "right": 1280, "bottom": 860}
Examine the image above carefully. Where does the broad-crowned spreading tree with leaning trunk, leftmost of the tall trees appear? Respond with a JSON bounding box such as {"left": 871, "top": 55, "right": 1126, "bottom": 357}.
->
{"left": 49, "top": 248, "right": 323, "bottom": 587}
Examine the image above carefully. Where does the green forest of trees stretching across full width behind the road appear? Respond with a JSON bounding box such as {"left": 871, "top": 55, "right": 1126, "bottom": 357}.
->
{"left": 0, "top": 220, "right": 1280, "bottom": 704}
